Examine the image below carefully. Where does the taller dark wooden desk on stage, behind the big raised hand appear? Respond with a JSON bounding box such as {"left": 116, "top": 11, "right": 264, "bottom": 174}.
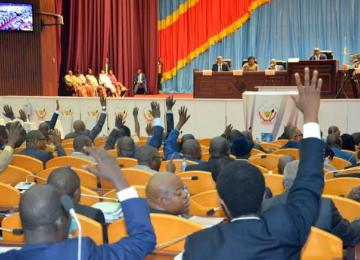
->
{"left": 288, "top": 60, "right": 338, "bottom": 98}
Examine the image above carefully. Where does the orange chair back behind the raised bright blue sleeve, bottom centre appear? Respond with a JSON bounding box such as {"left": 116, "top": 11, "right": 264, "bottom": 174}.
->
{"left": 108, "top": 214, "right": 204, "bottom": 251}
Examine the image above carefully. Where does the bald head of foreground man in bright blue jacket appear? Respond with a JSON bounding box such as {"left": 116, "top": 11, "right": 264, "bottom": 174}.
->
{"left": 19, "top": 184, "right": 70, "bottom": 243}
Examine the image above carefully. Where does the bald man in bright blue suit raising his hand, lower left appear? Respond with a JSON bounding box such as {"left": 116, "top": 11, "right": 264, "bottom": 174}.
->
{"left": 0, "top": 148, "right": 156, "bottom": 260}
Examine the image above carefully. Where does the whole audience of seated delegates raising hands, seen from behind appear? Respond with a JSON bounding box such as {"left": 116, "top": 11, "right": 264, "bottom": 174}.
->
{"left": 0, "top": 70, "right": 360, "bottom": 259}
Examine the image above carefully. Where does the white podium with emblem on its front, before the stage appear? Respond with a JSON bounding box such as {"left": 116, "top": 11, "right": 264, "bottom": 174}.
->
{"left": 243, "top": 88, "right": 303, "bottom": 142}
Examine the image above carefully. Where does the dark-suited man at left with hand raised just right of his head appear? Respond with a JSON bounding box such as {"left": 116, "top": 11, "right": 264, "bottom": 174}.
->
{"left": 19, "top": 130, "right": 65, "bottom": 166}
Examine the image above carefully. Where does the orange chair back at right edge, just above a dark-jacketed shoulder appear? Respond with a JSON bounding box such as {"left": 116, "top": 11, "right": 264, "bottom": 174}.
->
{"left": 323, "top": 195, "right": 360, "bottom": 222}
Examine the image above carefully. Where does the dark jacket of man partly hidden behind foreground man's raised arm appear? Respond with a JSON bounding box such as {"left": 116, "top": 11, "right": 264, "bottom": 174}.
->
{"left": 261, "top": 192, "right": 360, "bottom": 247}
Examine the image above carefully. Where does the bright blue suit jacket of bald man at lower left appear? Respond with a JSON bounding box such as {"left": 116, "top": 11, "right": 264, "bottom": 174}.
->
{"left": 0, "top": 198, "right": 156, "bottom": 260}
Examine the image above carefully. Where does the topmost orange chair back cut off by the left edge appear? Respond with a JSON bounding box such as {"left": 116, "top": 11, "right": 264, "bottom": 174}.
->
{"left": 0, "top": 165, "right": 34, "bottom": 186}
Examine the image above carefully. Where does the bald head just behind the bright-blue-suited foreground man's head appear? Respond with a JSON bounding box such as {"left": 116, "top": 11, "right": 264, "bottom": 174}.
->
{"left": 48, "top": 167, "right": 80, "bottom": 203}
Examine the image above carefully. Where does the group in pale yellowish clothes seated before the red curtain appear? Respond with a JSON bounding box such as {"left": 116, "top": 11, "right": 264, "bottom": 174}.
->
{"left": 63, "top": 68, "right": 128, "bottom": 97}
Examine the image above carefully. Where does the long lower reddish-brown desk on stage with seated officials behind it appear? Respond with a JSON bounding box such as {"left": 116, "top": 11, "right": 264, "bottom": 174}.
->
{"left": 194, "top": 70, "right": 288, "bottom": 98}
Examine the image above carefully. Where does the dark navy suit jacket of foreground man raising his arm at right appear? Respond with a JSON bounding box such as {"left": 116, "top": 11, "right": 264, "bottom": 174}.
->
{"left": 183, "top": 138, "right": 324, "bottom": 260}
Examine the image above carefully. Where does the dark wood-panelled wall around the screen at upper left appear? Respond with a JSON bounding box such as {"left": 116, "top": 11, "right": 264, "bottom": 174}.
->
{"left": 0, "top": 0, "right": 57, "bottom": 96}
